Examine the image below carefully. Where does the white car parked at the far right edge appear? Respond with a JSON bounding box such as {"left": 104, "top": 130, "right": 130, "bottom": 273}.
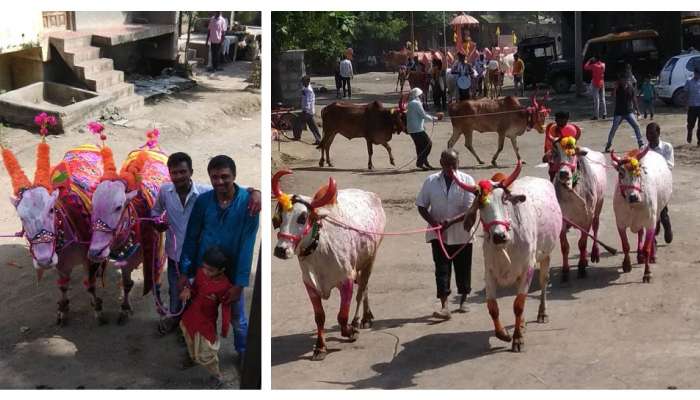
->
{"left": 656, "top": 51, "right": 700, "bottom": 107}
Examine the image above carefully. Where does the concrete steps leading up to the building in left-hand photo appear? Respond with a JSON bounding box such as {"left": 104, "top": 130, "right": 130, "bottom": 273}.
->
{"left": 49, "top": 31, "right": 144, "bottom": 112}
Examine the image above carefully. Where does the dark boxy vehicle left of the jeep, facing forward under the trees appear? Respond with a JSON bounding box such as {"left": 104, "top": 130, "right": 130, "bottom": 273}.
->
{"left": 518, "top": 36, "right": 557, "bottom": 87}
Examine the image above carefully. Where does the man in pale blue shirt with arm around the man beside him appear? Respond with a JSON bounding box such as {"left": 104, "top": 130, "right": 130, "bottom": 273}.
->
{"left": 151, "top": 153, "right": 260, "bottom": 335}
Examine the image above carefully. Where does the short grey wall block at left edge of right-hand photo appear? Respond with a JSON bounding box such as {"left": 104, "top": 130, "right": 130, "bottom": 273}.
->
{"left": 271, "top": 50, "right": 306, "bottom": 106}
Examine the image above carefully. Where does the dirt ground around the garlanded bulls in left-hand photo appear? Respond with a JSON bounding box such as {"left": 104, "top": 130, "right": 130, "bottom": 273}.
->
{"left": 0, "top": 62, "right": 260, "bottom": 389}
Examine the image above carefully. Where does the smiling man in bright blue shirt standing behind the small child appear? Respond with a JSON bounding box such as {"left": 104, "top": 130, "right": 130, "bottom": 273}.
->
{"left": 180, "top": 155, "right": 259, "bottom": 360}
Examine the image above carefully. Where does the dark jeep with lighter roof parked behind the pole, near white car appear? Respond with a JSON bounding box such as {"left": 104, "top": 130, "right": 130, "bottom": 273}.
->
{"left": 547, "top": 30, "right": 662, "bottom": 93}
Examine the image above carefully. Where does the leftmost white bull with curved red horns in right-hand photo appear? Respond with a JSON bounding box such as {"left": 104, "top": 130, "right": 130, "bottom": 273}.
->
{"left": 272, "top": 171, "right": 386, "bottom": 361}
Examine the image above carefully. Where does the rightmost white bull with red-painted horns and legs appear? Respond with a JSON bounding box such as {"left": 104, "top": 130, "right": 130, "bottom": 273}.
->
{"left": 610, "top": 147, "right": 673, "bottom": 283}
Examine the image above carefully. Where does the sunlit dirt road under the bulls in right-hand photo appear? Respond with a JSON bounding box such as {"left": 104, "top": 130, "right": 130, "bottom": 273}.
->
{"left": 270, "top": 73, "right": 700, "bottom": 389}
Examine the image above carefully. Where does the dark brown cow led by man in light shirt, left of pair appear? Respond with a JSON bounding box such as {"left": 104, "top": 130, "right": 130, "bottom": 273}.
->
{"left": 318, "top": 101, "right": 406, "bottom": 169}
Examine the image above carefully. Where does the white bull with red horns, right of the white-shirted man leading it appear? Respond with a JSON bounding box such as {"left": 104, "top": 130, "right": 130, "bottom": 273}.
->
{"left": 454, "top": 163, "right": 562, "bottom": 352}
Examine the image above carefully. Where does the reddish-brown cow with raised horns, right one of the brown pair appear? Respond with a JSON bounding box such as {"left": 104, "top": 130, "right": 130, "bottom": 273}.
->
{"left": 447, "top": 96, "right": 549, "bottom": 166}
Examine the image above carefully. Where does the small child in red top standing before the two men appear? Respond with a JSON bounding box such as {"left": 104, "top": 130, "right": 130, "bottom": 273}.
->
{"left": 180, "top": 246, "right": 233, "bottom": 388}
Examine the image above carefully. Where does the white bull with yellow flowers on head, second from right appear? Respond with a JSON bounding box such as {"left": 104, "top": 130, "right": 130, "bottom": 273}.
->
{"left": 547, "top": 133, "right": 607, "bottom": 282}
